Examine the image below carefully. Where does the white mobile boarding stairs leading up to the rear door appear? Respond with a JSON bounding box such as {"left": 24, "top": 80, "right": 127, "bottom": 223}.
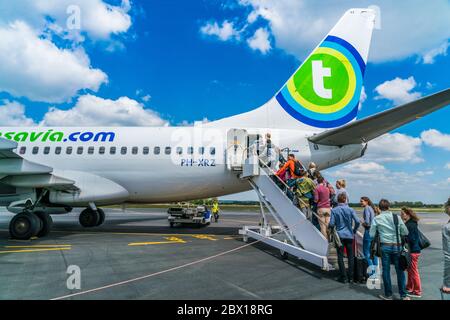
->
{"left": 227, "top": 129, "right": 362, "bottom": 271}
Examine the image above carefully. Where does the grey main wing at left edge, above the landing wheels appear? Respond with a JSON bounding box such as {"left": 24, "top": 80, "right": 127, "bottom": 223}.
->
{"left": 0, "top": 138, "right": 78, "bottom": 190}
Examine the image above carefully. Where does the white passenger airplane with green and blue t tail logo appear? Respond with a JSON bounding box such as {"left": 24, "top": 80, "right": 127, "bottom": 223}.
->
{"left": 0, "top": 8, "right": 450, "bottom": 239}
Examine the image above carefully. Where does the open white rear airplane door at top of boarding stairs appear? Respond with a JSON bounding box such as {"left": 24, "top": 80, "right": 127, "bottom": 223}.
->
{"left": 227, "top": 129, "right": 247, "bottom": 170}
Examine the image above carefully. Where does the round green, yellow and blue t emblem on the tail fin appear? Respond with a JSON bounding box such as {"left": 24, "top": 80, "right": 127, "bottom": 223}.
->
{"left": 276, "top": 36, "right": 365, "bottom": 128}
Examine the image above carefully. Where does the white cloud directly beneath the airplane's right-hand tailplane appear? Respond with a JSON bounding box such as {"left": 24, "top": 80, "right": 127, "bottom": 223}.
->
{"left": 364, "top": 133, "right": 423, "bottom": 163}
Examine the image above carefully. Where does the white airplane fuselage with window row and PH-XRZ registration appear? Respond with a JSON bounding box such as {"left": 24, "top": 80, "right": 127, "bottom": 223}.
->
{"left": 1, "top": 126, "right": 363, "bottom": 204}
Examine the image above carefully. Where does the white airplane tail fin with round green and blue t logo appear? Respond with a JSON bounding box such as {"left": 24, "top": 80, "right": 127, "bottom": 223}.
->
{"left": 211, "top": 9, "right": 376, "bottom": 129}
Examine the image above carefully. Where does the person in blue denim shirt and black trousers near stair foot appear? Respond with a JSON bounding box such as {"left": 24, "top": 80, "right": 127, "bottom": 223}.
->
{"left": 330, "top": 193, "right": 360, "bottom": 283}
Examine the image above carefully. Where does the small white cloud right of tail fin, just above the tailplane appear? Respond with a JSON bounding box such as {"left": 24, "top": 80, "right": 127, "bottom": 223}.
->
{"left": 375, "top": 76, "right": 421, "bottom": 104}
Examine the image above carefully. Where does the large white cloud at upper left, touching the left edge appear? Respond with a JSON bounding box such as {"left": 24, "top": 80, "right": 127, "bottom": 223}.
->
{"left": 0, "top": 21, "right": 107, "bottom": 102}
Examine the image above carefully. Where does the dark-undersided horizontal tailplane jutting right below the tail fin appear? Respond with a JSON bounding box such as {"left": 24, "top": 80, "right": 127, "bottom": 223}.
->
{"left": 308, "top": 89, "right": 450, "bottom": 146}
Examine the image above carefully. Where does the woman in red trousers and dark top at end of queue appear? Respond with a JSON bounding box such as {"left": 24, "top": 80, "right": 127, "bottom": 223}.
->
{"left": 401, "top": 208, "right": 422, "bottom": 298}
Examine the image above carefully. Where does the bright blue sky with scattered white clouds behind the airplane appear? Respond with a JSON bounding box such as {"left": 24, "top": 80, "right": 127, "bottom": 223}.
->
{"left": 0, "top": 0, "right": 450, "bottom": 203}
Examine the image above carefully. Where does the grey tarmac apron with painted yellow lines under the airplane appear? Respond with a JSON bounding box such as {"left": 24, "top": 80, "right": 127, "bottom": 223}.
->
{"left": 0, "top": 208, "right": 448, "bottom": 300}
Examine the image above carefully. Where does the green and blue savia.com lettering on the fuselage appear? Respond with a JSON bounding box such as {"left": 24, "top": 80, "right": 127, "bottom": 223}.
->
{"left": 0, "top": 129, "right": 116, "bottom": 142}
